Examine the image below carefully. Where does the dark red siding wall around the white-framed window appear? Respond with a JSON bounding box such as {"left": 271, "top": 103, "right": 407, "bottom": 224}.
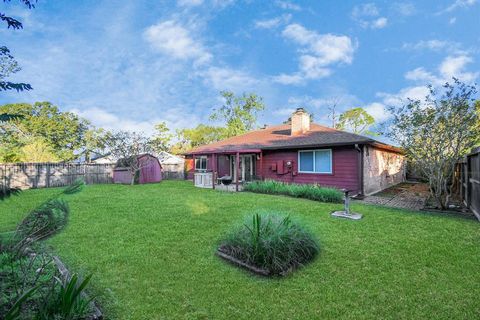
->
{"left": 257, "top": 146, "right": 360, "bottom": 193}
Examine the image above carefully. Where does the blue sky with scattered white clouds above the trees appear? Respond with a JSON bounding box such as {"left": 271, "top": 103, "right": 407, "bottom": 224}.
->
{"left": 0, "top": 0, "right": 480, "bottom": 140}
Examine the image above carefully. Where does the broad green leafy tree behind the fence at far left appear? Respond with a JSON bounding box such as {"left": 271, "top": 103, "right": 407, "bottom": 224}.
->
{"left": 0, "top": 102, "right": 88, "bottom": 161}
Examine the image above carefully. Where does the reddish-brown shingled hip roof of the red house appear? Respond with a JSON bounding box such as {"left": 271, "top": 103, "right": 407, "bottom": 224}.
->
{"left": 186, "top": 123, "right": 402, "bottom": 154}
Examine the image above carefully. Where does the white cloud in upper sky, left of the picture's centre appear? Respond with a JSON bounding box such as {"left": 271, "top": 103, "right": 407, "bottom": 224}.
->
{"left": 143, "top": 20, "right": 212, "bottom": 64}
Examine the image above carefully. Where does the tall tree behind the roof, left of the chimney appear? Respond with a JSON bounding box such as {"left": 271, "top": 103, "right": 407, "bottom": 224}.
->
{"left": 210, "top": 91, "right": 265, "bottom": 138}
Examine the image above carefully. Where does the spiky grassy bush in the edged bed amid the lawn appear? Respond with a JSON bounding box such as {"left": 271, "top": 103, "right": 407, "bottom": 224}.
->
{"left": 219, "top": 214, "right": 320, "bottom": 275}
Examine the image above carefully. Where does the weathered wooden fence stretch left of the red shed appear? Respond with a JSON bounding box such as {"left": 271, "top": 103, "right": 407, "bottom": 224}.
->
{"left": 0, "top": 163, "right": 115, "bottom": 189}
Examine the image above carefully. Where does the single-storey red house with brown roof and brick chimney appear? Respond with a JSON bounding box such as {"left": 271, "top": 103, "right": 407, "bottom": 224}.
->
{"left": 186, "top": 108, "right": 405, "bottom": 195}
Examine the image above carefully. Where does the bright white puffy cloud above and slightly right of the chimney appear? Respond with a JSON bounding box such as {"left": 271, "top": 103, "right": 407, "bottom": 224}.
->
{"left": 277, "top": 23, "right": 356, "bottom": 83}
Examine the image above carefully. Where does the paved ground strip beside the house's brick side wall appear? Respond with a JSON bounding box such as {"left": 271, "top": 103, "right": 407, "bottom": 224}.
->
{"left": 358, "top": 182, "right": 429, "bottom": 210}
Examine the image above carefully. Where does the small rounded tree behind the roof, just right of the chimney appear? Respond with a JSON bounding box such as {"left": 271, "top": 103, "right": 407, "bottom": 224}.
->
{"left": 336, "top": 108, "right": 376, "bottom": 135}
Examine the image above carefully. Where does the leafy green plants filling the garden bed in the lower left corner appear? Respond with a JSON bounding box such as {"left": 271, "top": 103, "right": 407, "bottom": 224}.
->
{"left": 0, "top": 181, "right": 91, "bottom": 320}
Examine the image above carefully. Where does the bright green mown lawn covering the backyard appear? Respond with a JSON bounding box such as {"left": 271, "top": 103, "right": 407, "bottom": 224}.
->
{"left": 0, "top": 181, "right": 480, "bottom": 320}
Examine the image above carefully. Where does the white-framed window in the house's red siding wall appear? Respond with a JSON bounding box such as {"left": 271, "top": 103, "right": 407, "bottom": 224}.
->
{"left": 298, "top": 149, "right": 332, "bottom": 173}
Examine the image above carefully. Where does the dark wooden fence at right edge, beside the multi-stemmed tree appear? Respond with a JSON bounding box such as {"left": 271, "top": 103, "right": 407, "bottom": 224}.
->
{"left": 460, "top": 147, "right": 480, "bottom": 220}
